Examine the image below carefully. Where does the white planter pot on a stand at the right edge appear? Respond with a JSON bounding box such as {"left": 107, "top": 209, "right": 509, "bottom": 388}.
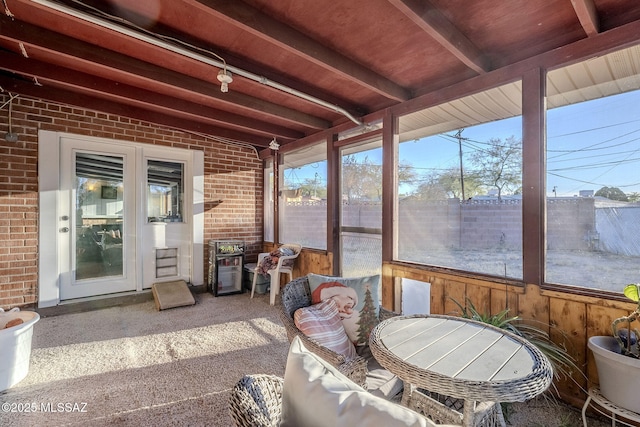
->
{"left": 589, "top": 336, "right": 640, "bottom": 413}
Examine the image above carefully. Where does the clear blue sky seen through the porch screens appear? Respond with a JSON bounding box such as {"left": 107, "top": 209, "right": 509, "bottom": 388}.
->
{"left": 286, "top": 91, "right": 640, "bottom": 201}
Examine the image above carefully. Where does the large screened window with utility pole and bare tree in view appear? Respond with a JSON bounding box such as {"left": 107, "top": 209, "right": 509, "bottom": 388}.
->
{"left": 397, "top": 82, "right": 522, "bottom": 279}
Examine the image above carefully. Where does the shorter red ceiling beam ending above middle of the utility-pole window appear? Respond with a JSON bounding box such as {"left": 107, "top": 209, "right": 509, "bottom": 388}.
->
{"left": 389, "top": 0, "right": 491, "bottom": 74}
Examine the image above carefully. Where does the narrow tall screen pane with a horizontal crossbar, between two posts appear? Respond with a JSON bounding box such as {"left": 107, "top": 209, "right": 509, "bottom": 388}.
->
{"left": 340, "top": 144, "right": 382, "bottom": 277}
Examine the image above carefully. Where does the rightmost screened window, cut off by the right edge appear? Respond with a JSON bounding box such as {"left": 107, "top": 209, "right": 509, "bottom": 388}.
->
{"left": 545, "top": 46, "right": 640, "bottom": 292}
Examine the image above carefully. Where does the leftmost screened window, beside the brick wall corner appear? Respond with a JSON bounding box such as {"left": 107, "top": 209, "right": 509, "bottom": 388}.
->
{"left": 279, "top": 142, "right": 327, "bottom": 249}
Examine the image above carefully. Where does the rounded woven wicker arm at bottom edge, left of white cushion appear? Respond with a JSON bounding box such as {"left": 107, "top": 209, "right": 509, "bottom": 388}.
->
{"left": 229, "top": 375, "right": 284, "bottom": 427}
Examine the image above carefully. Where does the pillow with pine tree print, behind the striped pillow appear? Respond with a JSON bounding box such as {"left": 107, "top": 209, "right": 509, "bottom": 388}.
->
{"left": 307, "top": 273, "right": 380, "bottom": 345}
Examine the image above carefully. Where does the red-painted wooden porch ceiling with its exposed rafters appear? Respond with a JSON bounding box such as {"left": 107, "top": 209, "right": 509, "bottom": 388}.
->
{"left": 0, "top": 0, "right": 640, "bottom": 153}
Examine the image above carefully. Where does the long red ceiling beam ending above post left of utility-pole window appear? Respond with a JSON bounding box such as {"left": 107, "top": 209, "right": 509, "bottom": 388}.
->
{"left": 185, "top": 0, "right": 411, "bottom": 102}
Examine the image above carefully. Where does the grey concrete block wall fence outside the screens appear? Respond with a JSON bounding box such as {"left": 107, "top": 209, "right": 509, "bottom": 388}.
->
{"left": 286, "top": 198, "right": 597, "bottom": 254}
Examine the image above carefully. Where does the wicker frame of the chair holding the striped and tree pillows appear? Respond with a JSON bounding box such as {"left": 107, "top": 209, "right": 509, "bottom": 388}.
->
{"left": 278, "top": 276, "right": 398, "bottom": 390}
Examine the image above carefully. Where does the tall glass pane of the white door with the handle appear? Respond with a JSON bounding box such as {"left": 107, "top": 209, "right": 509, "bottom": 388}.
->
{"left": 75, "top": 153, "right": 124, "bottom": 280}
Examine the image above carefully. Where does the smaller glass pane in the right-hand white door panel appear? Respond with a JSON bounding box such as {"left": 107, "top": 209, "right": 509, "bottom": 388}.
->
{"left": 147, "top": 160, "right": 184, "bottom": 222}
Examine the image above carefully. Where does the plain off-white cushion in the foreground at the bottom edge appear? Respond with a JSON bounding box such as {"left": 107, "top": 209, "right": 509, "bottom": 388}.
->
{"left": 280, "top": 337, "right": 435, "bottom": 427}
